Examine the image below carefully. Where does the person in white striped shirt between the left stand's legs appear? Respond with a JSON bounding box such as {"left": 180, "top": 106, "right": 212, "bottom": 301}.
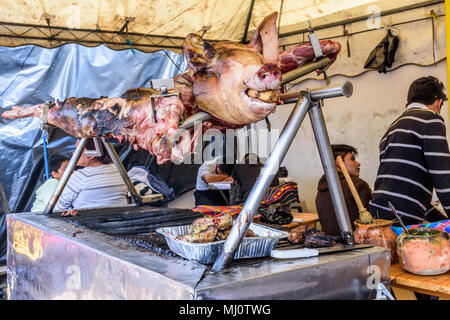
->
{"left": 55, "top": 139, "right": 128, "bottom": 215}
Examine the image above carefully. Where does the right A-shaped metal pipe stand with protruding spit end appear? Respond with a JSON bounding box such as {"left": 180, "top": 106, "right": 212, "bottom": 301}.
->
{"left": 212, "top": 82, "right": 352, "bottom": 271}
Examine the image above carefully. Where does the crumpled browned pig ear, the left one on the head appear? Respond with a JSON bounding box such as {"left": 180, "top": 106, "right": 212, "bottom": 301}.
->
{"left": 183, "top": 33, "right": 215, "bottom": 70}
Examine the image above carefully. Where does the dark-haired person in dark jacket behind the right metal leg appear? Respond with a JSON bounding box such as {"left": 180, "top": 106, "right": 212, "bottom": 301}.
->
{"left": 316, "top": 144, "right": 372, "bottom": 236}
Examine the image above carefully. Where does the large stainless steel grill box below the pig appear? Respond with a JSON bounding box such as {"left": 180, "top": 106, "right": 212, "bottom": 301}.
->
{"left": 7, "top": 207, "right": 390, "bottom": 300}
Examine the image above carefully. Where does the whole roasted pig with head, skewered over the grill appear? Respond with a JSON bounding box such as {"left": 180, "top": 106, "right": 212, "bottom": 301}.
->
{"left": 2, "top": 12, "right": 340, "bottom": 164}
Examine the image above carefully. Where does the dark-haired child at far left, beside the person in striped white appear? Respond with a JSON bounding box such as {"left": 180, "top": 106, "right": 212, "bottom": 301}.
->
{"left": 31, "top": 155, "right": 70, "bottom": 212}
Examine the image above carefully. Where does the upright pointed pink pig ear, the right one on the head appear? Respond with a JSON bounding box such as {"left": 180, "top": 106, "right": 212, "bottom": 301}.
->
{"left": 248, "top": 12, "right": 279, "bottom": 64}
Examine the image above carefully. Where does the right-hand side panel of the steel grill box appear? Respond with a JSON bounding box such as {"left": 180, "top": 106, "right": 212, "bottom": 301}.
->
{"left": 196, "top": 247, "right": 390, "bottom": 300}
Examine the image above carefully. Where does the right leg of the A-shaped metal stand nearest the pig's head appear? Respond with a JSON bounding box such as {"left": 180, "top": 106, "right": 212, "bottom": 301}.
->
{"left": 309, "top": 103, "right": 354, "bottom": 244}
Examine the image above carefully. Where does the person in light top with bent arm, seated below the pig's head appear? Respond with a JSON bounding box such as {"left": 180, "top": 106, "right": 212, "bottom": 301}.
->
{"left": 194, "top": 157, "right": 233, "bottom": 206}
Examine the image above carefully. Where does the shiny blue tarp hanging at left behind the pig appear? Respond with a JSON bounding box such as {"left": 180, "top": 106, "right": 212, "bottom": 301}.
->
{"left": 0, "top": 44, "right": 196, "bottom": 261}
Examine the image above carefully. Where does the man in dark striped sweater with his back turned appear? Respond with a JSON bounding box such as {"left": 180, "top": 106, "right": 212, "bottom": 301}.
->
{"left": 370, "top": 76, "right": 450, "bottom": 225}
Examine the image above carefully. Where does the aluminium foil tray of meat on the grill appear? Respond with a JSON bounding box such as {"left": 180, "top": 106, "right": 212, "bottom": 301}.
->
{"left": 156, "top": 223, "right": 288, "bottom": 264}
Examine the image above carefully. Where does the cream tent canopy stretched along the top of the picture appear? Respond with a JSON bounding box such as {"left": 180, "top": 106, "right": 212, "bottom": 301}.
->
{"left": 0, "top": 0, "right": 443, "bottom": 52}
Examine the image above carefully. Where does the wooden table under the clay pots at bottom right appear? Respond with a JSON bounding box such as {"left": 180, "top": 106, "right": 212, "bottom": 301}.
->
{"left": 391, "top": 263, "right": 450, "bottom": 300}
